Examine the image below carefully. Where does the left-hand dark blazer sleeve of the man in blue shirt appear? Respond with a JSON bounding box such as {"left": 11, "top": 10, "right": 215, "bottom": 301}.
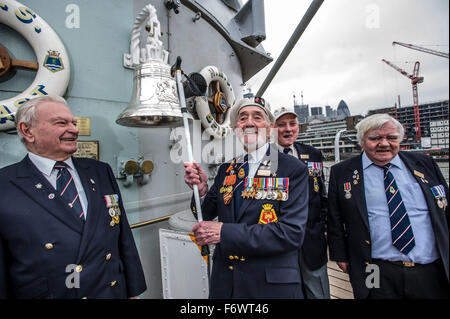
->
{"left": 327, "top": 166, "right": 348, "bottom": 262}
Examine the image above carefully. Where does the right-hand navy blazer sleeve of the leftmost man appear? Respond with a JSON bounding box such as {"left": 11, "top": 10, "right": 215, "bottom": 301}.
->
{"left": 107, "top": 165, "right": 147, "bottom": 298}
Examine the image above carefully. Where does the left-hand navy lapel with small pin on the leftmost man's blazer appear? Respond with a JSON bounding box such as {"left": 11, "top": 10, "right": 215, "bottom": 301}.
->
{"left": 11, "top": 155, "right": 83, "bottom": 233}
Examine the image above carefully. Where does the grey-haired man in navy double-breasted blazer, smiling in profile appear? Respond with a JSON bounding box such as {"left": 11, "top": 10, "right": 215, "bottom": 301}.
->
{"left": 0, "top": 96, "right": 146, "bottom": 299}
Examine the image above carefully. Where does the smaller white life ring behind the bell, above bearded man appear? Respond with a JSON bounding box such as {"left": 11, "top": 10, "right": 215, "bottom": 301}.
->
{"left": 194, "top": 65, "right": 235, "bottom": 139}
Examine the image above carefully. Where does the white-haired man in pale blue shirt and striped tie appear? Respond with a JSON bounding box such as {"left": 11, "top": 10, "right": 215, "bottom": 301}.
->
{"left": 328, "top": 114, "right": 449, "bottom": 298}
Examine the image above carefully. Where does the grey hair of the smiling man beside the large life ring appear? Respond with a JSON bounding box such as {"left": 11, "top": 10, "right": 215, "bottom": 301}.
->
{"left": 14, "top": 95, "right": 67, "bottom": 144}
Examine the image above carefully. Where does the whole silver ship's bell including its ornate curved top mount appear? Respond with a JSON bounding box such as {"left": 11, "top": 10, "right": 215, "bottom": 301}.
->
{"left": 116, "top": 4, "right": 183, "bottom": 127}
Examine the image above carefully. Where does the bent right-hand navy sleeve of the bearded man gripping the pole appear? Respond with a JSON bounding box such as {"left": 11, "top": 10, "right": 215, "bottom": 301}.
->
{"left": 220, "top": 165, "right": 309, "bottom": 256}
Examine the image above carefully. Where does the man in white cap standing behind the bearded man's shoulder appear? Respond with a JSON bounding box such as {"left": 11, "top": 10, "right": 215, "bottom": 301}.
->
{"left": 274, "top": 107, "right": 330, "bottom": 299}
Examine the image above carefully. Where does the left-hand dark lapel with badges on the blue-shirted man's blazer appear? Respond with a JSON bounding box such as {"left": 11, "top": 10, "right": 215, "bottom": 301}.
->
{"left": 346, "top": 153, "right": 369, "bottom": 231}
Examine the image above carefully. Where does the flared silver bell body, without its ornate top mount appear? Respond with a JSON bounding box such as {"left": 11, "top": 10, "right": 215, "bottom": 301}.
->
{"left": 116, "top": 60, "right": 183, "bottom": 127}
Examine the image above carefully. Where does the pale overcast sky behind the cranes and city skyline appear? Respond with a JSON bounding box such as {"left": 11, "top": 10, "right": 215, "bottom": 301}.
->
{"left": 243, "top": 0, "right": 449, "bottom": 115}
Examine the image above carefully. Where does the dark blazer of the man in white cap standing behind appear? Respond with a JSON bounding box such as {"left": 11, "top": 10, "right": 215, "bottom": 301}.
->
{"left": 294, "top": 142, "right": 328, "bottom": 270}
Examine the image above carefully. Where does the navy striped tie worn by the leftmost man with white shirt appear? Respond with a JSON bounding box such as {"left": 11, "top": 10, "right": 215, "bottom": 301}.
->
{"left": 54, "top": 162, "right": 84, "bottom": 221}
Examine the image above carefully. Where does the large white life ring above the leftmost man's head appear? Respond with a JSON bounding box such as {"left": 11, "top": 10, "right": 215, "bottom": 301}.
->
{"left": 0, "top": 0, "right": 70, "bottom": 131}
